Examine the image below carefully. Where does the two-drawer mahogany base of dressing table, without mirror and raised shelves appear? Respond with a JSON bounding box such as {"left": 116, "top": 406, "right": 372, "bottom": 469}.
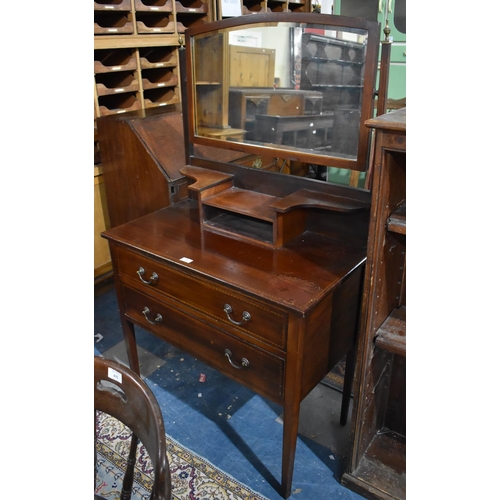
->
{"left": 103, "top": 199, "right": 365, "bottom": 497}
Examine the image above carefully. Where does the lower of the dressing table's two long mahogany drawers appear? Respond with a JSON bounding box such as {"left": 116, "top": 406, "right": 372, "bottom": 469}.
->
{"left": 123, "top": 287, "right": 285, "bottom": 403}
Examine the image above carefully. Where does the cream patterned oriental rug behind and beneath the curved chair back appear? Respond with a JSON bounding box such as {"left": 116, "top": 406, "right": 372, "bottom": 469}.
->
{"left": 95, "top": 412, "right": 268, "bottom": 500}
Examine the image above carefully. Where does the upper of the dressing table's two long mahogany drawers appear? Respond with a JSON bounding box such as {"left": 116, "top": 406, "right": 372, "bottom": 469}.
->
{"left": 116, "top": 248, "right": 288, "bottom": 350}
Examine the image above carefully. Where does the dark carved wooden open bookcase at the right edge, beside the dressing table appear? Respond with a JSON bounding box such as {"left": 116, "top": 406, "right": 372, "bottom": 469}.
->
{"left": 342, "top": 108, "right": 406, "bottom": 500}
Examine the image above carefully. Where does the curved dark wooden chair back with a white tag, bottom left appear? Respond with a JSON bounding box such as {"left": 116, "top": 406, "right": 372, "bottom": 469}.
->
{"left": 94, "top": 356, "right": 171, "bottom": 500}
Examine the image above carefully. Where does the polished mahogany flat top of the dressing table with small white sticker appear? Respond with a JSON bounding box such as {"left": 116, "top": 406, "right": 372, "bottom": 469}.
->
{"left": 103, "top": 199, "right": 366, "bottom": 314}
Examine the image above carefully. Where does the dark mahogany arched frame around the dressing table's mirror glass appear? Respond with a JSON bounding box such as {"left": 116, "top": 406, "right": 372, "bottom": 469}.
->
{"left": 183, "top": 12, "right": 380, "bottom": 171}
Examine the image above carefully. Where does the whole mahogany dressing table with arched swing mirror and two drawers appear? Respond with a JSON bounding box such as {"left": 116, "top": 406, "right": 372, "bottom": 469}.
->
{"left": 103, "top": 9, "right": 385, "bottom": 498}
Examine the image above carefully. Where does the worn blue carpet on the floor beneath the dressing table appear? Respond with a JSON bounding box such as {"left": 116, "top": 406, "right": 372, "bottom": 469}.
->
{"left": 94, "top": 290, "right": 363, "bottom": 500}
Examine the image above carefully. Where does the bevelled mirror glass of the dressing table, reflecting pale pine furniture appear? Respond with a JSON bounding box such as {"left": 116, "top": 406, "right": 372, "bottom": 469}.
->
{"left": 190, "top": 14, "right": 375, "bottom": 174}
